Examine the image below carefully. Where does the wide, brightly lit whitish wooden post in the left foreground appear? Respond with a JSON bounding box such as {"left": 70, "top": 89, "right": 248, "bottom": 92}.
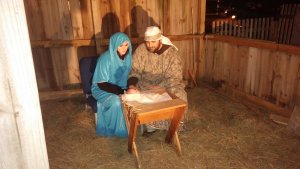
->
{"left": 0, "top": 0, "right": 49, "bottom": 169}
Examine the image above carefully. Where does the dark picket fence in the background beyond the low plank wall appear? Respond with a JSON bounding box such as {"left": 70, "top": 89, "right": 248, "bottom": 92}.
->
{"left": 212, "top": 4, "right": 300, "bottom": 44}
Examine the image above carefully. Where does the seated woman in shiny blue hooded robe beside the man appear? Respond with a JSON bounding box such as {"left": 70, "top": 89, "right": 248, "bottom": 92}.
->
{"left": 92, "top": 32, "right": 132, "bottom": 137}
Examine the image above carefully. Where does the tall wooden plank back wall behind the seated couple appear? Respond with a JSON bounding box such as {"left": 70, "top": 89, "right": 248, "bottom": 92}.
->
{"left": 24, "top": 0, "right": 200, "bottom": 91}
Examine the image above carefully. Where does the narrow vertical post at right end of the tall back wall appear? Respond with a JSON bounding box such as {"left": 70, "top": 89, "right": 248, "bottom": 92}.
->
{"left": 198, "top": 0, "right": 206, "bottom": 78}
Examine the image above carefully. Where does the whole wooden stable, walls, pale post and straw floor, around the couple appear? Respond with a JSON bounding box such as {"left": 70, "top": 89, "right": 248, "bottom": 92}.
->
{"left": 0, "top": 0, "right": 300, "bottom": 169}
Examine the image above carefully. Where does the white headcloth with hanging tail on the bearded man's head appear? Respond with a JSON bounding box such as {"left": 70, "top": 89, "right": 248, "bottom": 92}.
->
{"left": 144, "top": 26, "right": 178, "bottom": 50}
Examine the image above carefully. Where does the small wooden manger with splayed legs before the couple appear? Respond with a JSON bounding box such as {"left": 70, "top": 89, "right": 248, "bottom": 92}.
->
{"left": 122, "top": 91, "right": 187, "bottom": 168}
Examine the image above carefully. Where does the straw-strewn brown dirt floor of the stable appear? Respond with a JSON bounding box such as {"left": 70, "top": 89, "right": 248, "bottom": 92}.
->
{"left": 41, "top": 87, "right": 300, "bottom": 169}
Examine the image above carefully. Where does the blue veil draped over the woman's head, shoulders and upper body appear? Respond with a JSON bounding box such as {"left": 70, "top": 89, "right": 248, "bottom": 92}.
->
{"left": 92, "top": 32, "right": 132, "bottom": 90}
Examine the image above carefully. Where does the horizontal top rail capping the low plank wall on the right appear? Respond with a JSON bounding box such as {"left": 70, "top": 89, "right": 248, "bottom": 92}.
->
{"left": 205, "top": 35, "right": 300, "bottom": 55}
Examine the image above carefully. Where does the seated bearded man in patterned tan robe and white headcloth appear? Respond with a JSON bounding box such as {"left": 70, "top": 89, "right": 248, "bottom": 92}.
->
{"left": 128, "top": 26, "right": 187, "bottom": 132}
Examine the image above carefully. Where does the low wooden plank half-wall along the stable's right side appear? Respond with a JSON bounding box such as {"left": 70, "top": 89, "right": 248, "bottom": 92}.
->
{"left": 204, "top": 37, "right": 300, "bottom": 115}
